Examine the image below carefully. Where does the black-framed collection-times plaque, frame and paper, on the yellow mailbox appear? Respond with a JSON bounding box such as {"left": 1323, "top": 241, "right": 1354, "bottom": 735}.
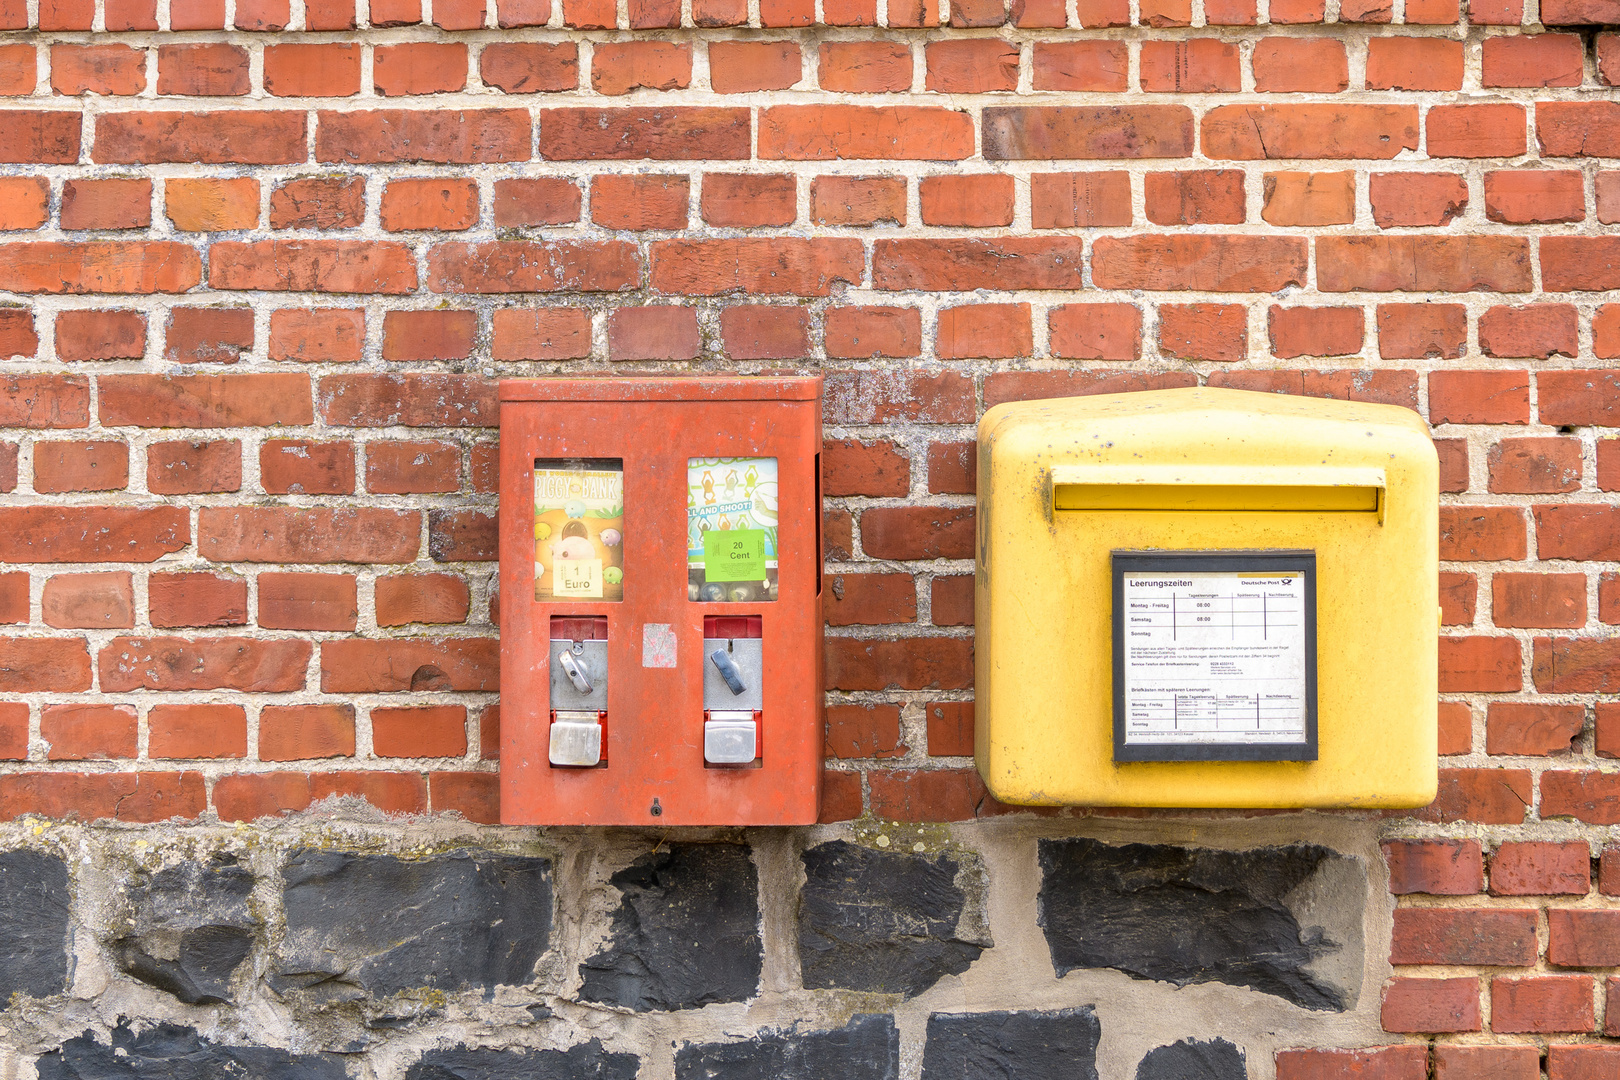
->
{"left": 1113, "top": 551, "right": 1317, "bottom": 761}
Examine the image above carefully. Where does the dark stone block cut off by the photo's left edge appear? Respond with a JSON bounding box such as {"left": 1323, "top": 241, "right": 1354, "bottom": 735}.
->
{"left": 0, "top": 850, "right": 73, "bottom": 1007}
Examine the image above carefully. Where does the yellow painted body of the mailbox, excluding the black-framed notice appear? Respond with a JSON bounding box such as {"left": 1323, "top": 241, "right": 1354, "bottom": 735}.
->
{"left": 975, "top": 389, "right": 1439, "bottom": 808}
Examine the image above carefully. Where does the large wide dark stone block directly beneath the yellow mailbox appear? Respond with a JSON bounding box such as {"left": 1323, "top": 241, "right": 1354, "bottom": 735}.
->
{"left": 1040, "top": 839, "right": 1361, "bottom": 1010}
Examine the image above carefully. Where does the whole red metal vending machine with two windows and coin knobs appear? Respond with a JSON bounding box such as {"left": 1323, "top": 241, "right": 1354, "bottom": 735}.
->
{"left": 501, "top": 377, "right": 823, "bottom": 826}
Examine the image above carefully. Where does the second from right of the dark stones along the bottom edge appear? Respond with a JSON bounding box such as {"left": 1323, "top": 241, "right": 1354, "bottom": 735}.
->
{"left": 922, "top": 1007, "right": 1102, "bottom": 1080}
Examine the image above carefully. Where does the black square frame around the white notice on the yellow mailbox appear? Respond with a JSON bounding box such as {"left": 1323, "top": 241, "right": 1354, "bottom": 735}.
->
{"left": 1111, "top": 549, "right": 1317, "bottom": 761}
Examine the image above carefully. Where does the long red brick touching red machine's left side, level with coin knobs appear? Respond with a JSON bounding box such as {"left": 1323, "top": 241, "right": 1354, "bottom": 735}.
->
{"left": 321, "top": 638, "right": 501, "bottom": 693}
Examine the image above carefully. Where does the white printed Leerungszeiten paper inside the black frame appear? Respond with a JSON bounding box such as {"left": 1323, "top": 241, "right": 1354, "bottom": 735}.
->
{"left": 1123, "top": 570, "right": 1306, "bottom": 746}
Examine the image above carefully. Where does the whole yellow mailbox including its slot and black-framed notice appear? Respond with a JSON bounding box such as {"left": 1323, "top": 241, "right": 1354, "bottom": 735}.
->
{"left": 975, "top": 389, "right": 1439, "bottom": 806}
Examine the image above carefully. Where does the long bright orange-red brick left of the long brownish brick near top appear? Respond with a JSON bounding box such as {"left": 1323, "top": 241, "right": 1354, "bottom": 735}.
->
{"left": 760, "top": 105, "right": 990, "bottom": 162}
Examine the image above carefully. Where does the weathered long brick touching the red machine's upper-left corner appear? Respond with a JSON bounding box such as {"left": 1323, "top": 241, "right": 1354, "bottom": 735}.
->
{"left": 316, "top": 374, "right": 499, "bottom": 427}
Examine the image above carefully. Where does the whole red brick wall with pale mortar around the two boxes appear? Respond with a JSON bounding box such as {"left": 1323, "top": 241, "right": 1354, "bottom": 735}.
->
{"left": 0, "top": 0, "right": 1620, "bottom": 1062}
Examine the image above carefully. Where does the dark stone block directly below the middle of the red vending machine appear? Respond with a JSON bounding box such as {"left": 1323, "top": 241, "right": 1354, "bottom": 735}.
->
{"left": 580, "top": 844, "right": 765, "bottom": 1012}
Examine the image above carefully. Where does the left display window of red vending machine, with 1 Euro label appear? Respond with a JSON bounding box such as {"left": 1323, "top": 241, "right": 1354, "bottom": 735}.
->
{"left": 535, "top": 460, "right": 624, "bottom": 601}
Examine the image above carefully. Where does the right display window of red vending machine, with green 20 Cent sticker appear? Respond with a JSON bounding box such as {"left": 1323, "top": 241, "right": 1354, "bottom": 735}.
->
{"left": 687, "top": 458, "right": 779, "bottom": 602}
